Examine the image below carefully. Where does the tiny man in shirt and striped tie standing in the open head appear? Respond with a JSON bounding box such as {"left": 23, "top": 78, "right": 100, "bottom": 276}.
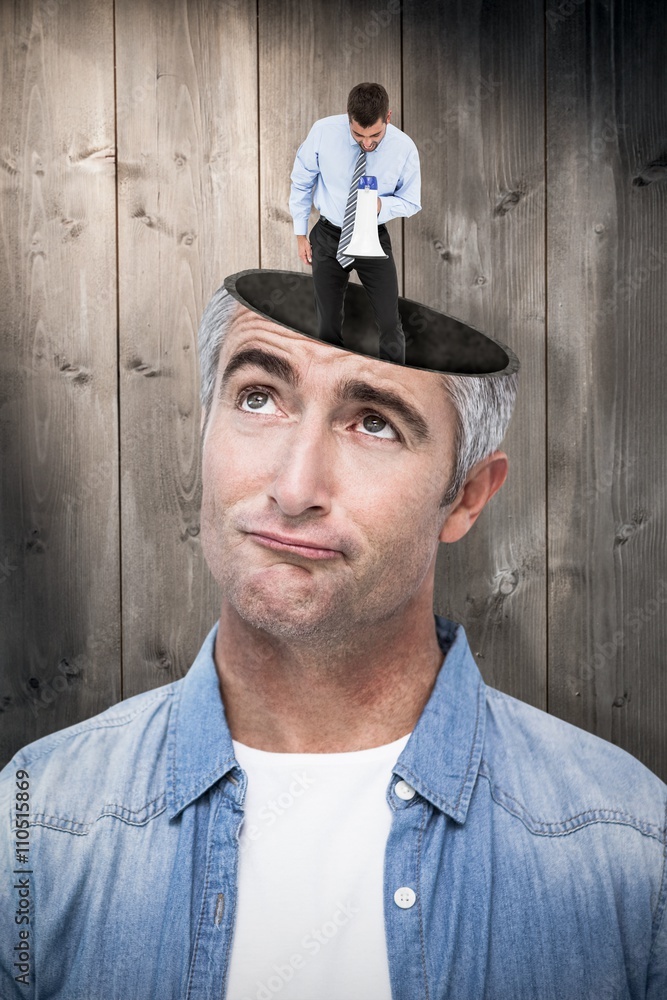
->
{"left": 290, "top": 83, "right": 421, "bottom": 364}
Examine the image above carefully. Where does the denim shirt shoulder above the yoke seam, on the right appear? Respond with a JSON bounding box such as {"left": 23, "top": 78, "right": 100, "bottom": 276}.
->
{"left": 480, "top": 688, "right": 667, "bottom": 843}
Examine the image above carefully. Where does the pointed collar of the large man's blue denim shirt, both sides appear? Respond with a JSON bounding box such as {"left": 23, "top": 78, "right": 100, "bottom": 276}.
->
{"left": 167, "top": 616, "right": 485, "bottom": 823}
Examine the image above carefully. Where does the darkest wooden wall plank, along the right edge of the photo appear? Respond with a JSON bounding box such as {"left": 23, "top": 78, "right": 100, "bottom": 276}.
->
{"left": 546, "top": 0, "right": 667, "bottom": 778}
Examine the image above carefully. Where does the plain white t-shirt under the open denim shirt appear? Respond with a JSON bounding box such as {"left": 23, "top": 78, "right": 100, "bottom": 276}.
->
{"left": 227, "top": 734, "right": 409, "bottom": 1000}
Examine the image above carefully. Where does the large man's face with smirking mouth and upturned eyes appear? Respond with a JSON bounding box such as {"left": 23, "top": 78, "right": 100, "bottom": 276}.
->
{"left": 202, "top": 307, "right": 454, "bottom": 641}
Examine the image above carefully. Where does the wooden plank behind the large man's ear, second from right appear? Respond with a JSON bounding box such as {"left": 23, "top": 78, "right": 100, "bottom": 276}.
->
{"left": 403, "top": 0, "right": 546, "bottom": 708}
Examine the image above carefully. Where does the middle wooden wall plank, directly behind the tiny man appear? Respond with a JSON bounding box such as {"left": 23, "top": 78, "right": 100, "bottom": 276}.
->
{"left": 259, "top": 0, "right": 403, "bottom": 290}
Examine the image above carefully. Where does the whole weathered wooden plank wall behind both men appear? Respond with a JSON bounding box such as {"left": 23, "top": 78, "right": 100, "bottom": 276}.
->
{"left": 0, "top": 0, "right": 667, "bottom": 778}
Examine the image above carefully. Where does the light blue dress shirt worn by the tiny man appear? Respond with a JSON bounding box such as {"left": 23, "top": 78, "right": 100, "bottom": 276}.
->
{"left": 289, "top": 115, "right": 421, "bottom": 236}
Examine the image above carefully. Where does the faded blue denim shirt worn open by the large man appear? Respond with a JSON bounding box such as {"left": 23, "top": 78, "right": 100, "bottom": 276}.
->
{"left": 0, "top": 619, "right": 667, "bottom": 1000}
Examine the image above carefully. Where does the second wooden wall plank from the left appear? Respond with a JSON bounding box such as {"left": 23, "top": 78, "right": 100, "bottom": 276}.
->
{"left": 116, "top": 0, "right": 259, "bottom": 695}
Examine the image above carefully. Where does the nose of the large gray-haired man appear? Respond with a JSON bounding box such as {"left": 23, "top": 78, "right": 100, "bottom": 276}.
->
{"left": 269, "top": 418, "right": 333, "bottom": 517}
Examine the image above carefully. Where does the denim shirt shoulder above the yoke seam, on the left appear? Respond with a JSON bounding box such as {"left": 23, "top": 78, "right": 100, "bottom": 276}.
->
{"left": 0, "top": 681, "right": 182, "bottom": 832}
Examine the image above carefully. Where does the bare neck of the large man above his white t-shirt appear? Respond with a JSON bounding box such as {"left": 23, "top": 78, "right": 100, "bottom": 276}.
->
{"left": 215, "top": 604, "right": 442, "bottom": 753}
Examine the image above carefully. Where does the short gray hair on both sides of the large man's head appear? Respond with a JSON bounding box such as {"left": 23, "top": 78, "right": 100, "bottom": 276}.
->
{"left": 199, "top": 285, "right": 518, "bottom": 506}
